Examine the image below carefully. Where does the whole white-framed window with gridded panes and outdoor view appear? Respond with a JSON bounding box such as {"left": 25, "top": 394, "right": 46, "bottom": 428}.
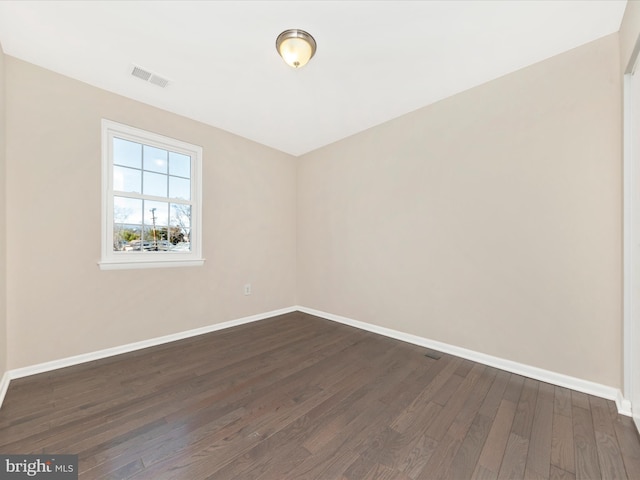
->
{"left": 100, "top": 120, "right": 203, "bottom": 268}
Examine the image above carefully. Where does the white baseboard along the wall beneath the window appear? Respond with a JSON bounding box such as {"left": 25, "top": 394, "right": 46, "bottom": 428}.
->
{"left": 0, "top": 307, "right": 297, "bottom": 407}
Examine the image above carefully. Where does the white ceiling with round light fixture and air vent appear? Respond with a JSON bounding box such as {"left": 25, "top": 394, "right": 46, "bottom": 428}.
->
{"left": 0, "top": 0, "right": 626, "bottom": 155}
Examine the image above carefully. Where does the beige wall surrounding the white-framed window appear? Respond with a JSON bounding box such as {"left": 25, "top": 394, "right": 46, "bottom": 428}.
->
{"left": 5, "top": 57, "right": 296, "bottom": 368}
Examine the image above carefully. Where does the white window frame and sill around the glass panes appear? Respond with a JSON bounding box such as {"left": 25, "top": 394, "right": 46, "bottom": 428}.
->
{"left": 98, "top": 119, "right": 205, "bottom": 270}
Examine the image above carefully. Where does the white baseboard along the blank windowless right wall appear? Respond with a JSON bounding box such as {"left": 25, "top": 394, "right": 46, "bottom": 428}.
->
{"left": 297, "top": 306, "right": 631, "bottom": 416}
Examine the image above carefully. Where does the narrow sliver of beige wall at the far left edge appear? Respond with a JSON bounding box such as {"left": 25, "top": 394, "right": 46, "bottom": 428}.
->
{"left": 0, "top": 45, "right": 7, "bottom": 378}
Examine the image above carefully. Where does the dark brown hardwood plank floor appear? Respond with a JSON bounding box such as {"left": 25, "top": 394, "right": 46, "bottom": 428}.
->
{"left": 0, "top": 313, "right": 640, "bottom": 480}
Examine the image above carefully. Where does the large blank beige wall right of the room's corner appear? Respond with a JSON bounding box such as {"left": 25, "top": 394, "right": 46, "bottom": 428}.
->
{"left": 298, "top": 34, "right": 622, "bottom": 387}
